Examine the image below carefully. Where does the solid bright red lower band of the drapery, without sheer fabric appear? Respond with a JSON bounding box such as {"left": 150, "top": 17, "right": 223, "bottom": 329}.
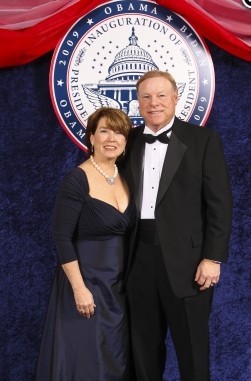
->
{"left": 0, "top": 0, "right": 251, "bottom": 67}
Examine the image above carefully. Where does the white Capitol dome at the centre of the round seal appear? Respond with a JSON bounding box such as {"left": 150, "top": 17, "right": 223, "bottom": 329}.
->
{"left": 106, "top": 27, "right": 158, "bottom": 81}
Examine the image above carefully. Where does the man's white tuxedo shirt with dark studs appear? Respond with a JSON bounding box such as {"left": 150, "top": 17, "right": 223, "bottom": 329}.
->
{"left": 141, "top": 118, "right": 174, "bottom": 219}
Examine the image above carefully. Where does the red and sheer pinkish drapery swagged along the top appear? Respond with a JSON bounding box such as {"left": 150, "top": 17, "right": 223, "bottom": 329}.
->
{"left": 0, "top": 0, "right": 251, "bottom": 67}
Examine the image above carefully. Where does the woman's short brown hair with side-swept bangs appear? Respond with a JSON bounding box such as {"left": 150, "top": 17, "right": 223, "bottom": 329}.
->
{"left": 85, "top": 107, "right": 132, "bottom": 154}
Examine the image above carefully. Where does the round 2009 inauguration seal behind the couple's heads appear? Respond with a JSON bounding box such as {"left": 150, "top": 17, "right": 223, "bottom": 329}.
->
{"left": 50, "top": 0, "right": 215, "bottom": 150}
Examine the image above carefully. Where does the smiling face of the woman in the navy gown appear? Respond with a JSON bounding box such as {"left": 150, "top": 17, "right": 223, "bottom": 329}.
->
{"left": 90, "top": 117, "right": 126, "bottom": 160}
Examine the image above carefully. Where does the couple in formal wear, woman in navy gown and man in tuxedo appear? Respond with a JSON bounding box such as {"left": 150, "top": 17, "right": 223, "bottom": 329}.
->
{"left": 36, "top": 71, "right": 231, "bottom": 381}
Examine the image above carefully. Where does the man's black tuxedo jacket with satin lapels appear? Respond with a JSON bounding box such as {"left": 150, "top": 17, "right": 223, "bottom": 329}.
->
{"left": 125, "top": 118, "right": 232, "bottom": 297}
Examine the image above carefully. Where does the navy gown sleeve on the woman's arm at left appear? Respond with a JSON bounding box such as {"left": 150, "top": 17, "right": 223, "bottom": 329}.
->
{"left": 53, "top": 168, "right": 88, "bottom": 264}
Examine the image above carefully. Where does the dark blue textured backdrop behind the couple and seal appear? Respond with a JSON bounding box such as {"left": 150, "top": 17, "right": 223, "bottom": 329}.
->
{"left": 0, "top": 43, "right": 251, "bottom": 381}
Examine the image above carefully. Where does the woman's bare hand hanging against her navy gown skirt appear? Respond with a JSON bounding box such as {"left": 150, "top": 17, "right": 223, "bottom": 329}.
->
{"left": 73, "top": 286, "right": 96, "bottom": 319}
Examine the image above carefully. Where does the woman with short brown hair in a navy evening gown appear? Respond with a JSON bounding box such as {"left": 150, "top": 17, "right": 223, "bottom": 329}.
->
{"left": 36, "top": 107, "right": 135, "bottom": 381}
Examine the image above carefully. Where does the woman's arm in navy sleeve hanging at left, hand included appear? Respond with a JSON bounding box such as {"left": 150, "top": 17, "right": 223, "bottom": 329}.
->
{"left": 53, "top": 171, "right": 96, "bottom": 318}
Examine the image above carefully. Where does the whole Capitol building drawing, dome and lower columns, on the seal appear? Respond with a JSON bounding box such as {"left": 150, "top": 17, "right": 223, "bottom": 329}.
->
{"left": 83, "top": 27, "right": 158, "bottom": 117}
